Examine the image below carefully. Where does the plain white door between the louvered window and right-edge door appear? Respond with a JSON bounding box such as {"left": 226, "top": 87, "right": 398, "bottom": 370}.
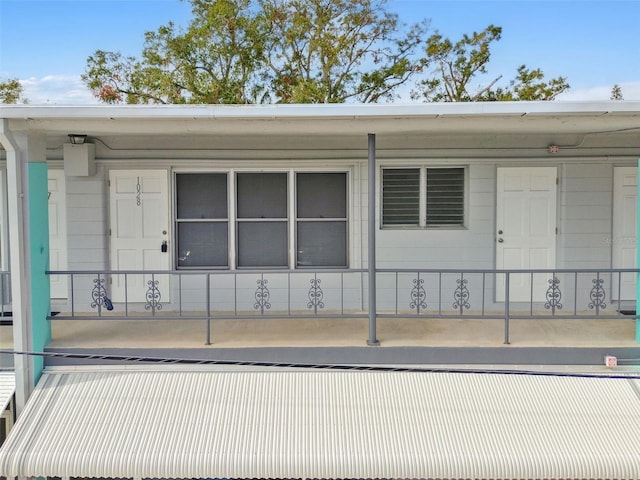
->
{"left": 496, "top": 167, "right": 557, "bottom": 302}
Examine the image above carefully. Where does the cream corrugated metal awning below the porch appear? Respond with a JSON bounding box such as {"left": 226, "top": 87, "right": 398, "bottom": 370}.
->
{"left": 0, "top": 370, "right": 640, "bottom": 479}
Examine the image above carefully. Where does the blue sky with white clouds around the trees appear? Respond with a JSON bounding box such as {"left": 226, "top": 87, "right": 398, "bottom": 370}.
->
{"left": 0, "top": 0, "right": 640, "bottom": 105}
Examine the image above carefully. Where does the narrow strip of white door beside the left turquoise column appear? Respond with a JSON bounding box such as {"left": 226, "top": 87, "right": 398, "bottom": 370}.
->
{"left": 48, "top": 170, "right": 69, "bottom": 298}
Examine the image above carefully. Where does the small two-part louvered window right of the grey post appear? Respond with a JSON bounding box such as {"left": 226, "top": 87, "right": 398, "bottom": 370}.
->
{"left": 382, "top": 167, "right": 465, "bottom": 227}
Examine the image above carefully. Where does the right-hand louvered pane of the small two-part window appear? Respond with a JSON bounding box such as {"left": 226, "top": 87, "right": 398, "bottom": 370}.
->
{"left": 426, "top": 168, "right": 464, "bottom": 226}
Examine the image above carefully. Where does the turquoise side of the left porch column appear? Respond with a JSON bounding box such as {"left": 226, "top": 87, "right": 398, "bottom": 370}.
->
{"left": 28, "top": 163, "right": 51, "bottom": 384}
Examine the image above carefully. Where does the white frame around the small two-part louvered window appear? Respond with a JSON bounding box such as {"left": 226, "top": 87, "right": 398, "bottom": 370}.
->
{"left": 379, "top": 163, "right": 469, "bottom": 230}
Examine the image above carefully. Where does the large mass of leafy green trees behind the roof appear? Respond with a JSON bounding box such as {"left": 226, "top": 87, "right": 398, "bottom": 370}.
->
{"left": 82, "top": 0, "right": 568, "bottom": 104}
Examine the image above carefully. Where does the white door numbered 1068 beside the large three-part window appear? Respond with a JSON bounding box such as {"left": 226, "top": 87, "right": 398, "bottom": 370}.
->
{"left": 109, "top": 170, "right": 170, "bottom": 303}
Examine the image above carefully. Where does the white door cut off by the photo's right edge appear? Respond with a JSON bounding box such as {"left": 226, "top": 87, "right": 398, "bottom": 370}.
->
{"left": 611, "top": 167, "right": 638, "bottom": 300}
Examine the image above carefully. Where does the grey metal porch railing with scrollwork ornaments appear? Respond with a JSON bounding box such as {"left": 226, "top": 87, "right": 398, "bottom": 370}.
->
{"left": 47, "top": 269, "right": 640, "bottom": 344}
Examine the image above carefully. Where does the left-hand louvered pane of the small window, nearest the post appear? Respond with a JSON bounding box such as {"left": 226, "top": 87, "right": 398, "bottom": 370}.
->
{"left": 382, "top": 168, "right": 420, "bottom": 226}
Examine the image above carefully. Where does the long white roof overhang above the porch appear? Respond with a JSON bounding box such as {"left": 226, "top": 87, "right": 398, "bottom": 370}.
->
{"left": 0, "top": 101, "right": 640, "bottom": 152}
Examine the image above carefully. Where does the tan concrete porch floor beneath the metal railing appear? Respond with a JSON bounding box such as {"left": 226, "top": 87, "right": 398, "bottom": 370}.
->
{"left": 48, "top": 317, "right": 640, "bottom": 350}
